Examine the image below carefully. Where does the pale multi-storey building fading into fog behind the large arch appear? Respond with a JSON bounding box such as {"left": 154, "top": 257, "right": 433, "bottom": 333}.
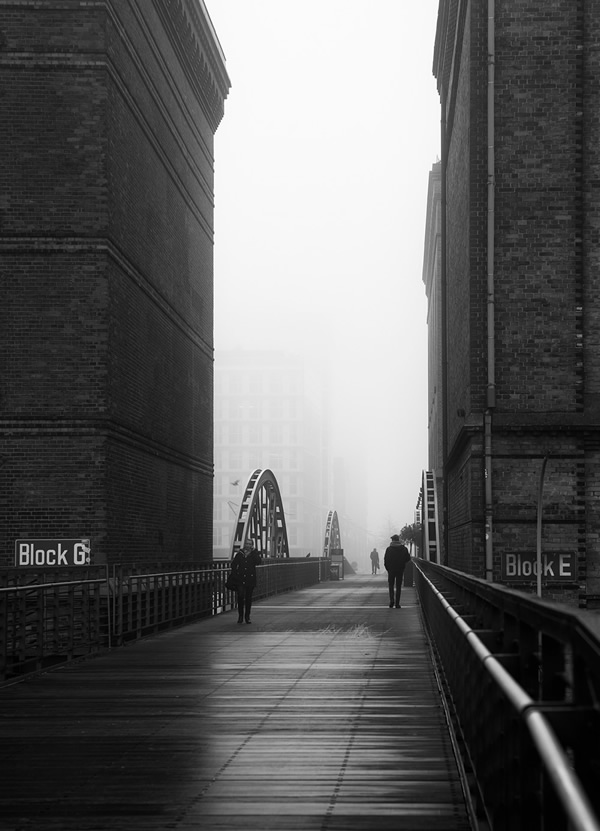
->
{"left": 213, "top": 350, "right": 335, "bottom": 558}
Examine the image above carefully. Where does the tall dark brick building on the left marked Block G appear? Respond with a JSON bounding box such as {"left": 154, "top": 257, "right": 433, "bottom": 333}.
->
{"left": 0, "top": 0, "right": 229, "bottom": 564}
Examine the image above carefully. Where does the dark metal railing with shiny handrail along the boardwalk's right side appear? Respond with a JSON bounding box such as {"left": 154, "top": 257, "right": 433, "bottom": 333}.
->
{"left": 414, "top": 560, "right": 600, "bottom": 831}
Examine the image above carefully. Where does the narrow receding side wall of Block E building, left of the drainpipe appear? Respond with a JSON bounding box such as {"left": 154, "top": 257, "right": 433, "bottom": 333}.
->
{"left": 442, "top": 4, "right": 487, "bottom": 576}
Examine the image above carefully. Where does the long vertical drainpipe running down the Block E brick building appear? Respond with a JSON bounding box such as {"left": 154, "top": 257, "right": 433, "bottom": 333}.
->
{"left": 484, "top": 0, "right": 496, "bottom": 581}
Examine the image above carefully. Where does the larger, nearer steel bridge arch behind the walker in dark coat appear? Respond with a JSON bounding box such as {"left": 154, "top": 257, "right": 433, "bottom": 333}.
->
{"left": 231, "top": 469, "right": 290, "bottom": 557}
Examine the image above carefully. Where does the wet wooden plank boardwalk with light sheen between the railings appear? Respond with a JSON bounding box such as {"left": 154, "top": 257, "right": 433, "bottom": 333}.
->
{"left": 0, "top": 576, "right": 470, "bottom": 831}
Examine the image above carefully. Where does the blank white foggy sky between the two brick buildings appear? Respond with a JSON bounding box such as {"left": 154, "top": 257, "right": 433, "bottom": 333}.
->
{"left": 205, "top": 0, "right": 440, "bottom": 532}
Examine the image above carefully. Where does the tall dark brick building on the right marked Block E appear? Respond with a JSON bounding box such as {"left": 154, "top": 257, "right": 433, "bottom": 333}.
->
{"left": 434, "top": 0, "right": 600, "bottom": 607}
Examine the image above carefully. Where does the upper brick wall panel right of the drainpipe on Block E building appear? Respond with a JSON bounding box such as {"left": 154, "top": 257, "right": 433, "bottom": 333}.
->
{"left": 495, "top": 0, "right": 583, "bottom": 412}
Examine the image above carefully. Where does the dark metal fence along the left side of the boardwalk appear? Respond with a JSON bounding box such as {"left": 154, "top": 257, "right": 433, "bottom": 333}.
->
{"left": 0, "top": 558, "right": 329, "bottom": 681}
